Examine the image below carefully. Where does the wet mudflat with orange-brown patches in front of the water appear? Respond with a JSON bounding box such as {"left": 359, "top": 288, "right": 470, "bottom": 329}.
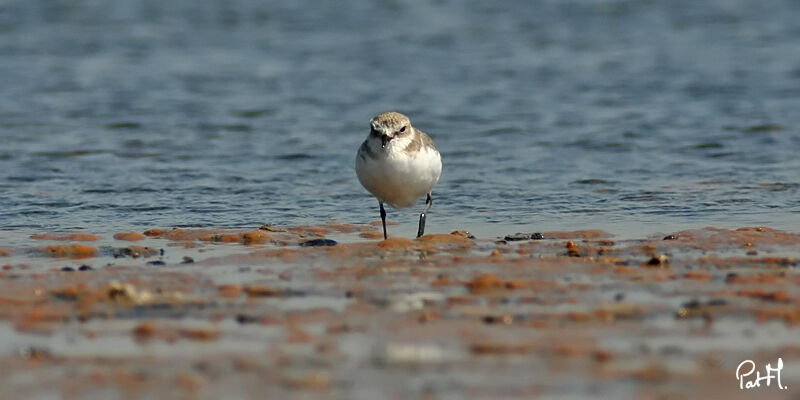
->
{"left": 0, "top": 222, "right": 800, "bottom": 398}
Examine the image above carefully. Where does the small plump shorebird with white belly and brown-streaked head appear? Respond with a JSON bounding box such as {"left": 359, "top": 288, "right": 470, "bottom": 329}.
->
{"left": 356, "top": 111, "right": 442, "bottom": 239}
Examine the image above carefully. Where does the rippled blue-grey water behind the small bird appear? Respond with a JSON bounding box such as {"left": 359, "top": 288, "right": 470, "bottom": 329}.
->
{"left": 0, "top": 0, "right": 800, "bottom": 236}
